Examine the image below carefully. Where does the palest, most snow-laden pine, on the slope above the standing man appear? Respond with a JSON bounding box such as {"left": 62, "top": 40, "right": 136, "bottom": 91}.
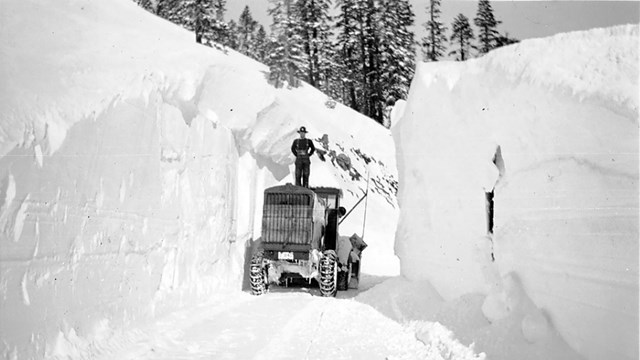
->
{"left": 267, "top": 0, "right": 304, "bottom": 87}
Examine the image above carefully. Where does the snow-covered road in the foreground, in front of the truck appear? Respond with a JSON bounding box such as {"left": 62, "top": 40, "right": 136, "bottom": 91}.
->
{"left": 103, "top": 282, "right": 439, "bottom": 359}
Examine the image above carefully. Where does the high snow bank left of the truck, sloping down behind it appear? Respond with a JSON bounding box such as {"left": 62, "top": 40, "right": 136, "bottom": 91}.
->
{"left": 0, "top": 0, "right": 397, "bottom": 359}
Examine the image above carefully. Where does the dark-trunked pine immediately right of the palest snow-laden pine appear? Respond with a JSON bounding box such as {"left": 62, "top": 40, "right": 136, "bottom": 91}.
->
{"left": 294, "top": 0, "right": 331, "bottom": 89}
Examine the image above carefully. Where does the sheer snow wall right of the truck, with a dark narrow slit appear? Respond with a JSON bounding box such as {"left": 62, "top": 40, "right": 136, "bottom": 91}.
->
{"left": 394, "top": 26, "right": 639, "bottom": 359}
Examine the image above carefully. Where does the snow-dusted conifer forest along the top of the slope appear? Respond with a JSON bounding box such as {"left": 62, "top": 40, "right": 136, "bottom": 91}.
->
{"left": 134, "top": 0, "right": 518, "bottom": 126}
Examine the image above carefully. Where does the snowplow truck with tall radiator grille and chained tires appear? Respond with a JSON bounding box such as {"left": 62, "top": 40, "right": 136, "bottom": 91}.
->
{"left": 249, "top": 184, "right": 366, "bottom": 296}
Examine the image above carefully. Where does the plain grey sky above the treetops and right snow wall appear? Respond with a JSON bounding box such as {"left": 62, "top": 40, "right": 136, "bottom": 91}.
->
{"left": 226, "top": 0, "right": 640, "bottom": 39}
